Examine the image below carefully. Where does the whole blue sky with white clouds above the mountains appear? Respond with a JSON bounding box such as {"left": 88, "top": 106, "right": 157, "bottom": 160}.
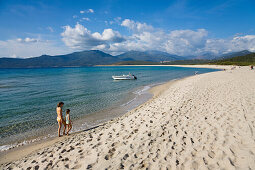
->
{"left": 0, "top": 0, "right": 255, "bottom": 58}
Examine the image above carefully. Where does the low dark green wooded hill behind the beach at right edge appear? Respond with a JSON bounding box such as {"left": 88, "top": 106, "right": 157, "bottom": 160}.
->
{"left": 210, "top": 53, "right": 255, "bottom": 66}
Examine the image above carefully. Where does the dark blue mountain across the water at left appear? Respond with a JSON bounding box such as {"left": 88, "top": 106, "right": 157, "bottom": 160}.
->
{"left": 0, "top": 50, "right": 121, "bottom": 68}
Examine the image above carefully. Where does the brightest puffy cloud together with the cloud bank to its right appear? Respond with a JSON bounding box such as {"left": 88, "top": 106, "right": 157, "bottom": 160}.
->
{"left": 58, "top": 19, "right": 255, "bottom": 56}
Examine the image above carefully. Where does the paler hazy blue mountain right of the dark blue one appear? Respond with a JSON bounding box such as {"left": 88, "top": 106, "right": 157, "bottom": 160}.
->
{"left": 117, "top": 50, "right": 183, "bottom": 62}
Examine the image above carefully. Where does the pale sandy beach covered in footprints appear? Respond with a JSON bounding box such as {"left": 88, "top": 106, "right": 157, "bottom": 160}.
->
{"left": 0, "top": 66, "right": 255, "bottom": 170}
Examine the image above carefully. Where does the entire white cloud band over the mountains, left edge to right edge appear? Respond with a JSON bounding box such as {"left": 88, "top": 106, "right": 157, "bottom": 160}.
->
{"left": 3, "top": 17, "right": 255, "bottom": 57}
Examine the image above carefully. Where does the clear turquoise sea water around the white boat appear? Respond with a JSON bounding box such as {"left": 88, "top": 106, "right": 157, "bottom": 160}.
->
{"left": 0, "top": 66, "right": 219, "bottom": 149}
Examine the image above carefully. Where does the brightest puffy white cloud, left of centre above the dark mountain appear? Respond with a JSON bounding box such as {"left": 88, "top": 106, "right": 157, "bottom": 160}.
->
{"left": 61, "top": 23, "right": 125, "bottom": 49}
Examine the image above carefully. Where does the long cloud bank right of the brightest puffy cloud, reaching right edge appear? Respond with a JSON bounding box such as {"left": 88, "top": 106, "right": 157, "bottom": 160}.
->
{"left": 117, "top": 19, "right": 255, "bottom": 56}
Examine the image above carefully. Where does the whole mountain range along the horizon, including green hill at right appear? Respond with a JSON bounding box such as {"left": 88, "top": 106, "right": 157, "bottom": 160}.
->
{"left": 0, "top": 50, "right": 254, "bottom": 68}
